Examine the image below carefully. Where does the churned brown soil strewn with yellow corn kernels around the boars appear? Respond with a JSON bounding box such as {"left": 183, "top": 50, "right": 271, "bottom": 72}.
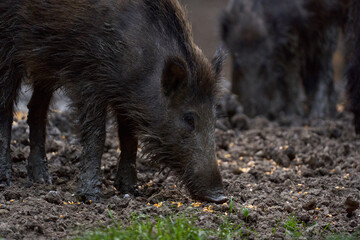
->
{"left": 0, "top": 109, "right": 360, "bottom": 239}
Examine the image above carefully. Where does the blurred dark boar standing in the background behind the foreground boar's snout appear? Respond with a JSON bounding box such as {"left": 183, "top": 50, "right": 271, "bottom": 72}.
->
{"left": 221, "top": 0, "right": 343, "bottom": 117}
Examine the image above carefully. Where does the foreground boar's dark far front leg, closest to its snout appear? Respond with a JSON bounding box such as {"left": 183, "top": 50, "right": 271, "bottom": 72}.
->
{"left": 114, "top": 117, "right": 138, "bottom": 193}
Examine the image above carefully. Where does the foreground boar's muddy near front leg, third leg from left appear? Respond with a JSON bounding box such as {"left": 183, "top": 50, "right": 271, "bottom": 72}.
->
{"left": 77, "top": 106, "right": 107, "bottom": 202}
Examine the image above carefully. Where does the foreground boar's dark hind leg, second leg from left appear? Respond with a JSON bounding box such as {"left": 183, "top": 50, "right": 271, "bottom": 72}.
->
{"left": 27, "top": 85, "right": 53, "bottom": 184}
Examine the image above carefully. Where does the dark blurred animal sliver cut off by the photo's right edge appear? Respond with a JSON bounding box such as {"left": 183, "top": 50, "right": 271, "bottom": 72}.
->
{"left": 347, "top": 0, "right": 360, "bottom": 134}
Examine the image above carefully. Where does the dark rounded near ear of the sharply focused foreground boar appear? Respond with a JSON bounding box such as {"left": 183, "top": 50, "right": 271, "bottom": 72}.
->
{"left": 161, "top": 57, "right": 189, "bottom": 97}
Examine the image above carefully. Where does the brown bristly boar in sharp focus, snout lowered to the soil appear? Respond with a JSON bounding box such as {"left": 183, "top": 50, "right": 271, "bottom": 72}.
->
{"left": 0, "top": 0, "right": 226, "bottom": 202}
